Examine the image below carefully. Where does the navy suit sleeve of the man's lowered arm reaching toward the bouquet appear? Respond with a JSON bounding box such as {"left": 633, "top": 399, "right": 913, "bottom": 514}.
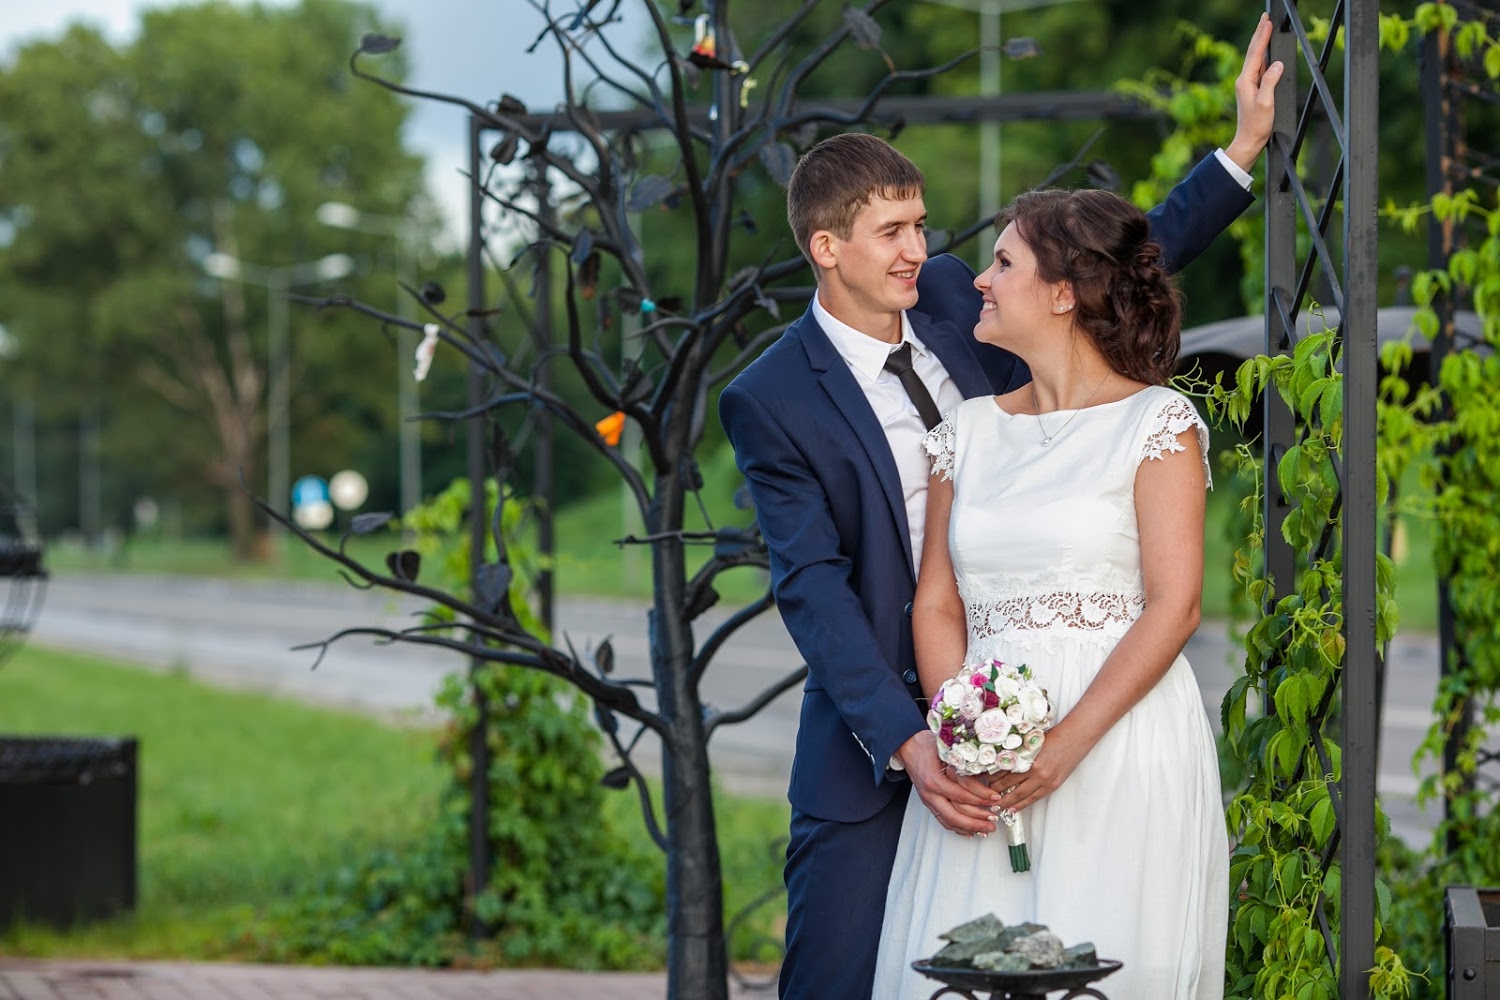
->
{"left": 719, "top": 385, "right": 926, "bottom": 783}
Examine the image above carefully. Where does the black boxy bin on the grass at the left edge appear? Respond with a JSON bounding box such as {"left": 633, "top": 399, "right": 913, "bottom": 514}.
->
{"left": 0, "top": 736, "right": 137, "bottom": 927}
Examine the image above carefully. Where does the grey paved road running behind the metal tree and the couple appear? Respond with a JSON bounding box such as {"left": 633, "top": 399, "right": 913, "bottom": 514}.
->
{"left": 33, "top": 574, "right": 1437, "bottom": 841}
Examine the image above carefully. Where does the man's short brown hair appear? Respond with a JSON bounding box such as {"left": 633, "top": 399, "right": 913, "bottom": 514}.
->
{"left": 786, "top": 132, "right": 927, "bottom": 261}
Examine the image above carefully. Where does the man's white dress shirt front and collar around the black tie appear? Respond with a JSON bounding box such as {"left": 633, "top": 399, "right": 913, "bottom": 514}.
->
{"left": 813, "top": 295, "right": 963, "bottom": 570}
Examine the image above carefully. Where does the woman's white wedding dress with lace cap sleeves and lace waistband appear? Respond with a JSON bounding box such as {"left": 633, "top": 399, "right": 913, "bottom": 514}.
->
{"left": 873, "top": 387, "right": 1229, "bottom": 1000}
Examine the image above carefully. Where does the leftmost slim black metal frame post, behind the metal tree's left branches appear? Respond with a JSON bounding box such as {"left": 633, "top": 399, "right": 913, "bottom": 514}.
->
{"left": 467, "top": 117, "right": 491, "bottom": 939}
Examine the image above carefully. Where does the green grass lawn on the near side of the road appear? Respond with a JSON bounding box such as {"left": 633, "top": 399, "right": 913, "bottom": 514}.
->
{"left": 0, "top": 646, "right": 788, "bottom": 958}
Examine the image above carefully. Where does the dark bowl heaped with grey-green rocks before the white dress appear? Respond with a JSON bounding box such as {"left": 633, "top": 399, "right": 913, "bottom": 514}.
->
{"left": 912, "top": 913, "right": 1122, "bottom": 997}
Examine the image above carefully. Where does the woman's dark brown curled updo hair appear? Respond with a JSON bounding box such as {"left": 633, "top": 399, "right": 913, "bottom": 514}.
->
{"left": 995, "top": 190, "right": 1182, "bottom": 385}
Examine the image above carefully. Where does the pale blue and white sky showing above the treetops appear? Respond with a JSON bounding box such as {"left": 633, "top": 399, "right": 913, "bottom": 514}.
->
{"left": 0, "top": 0, "right": 579, "bottom": 238}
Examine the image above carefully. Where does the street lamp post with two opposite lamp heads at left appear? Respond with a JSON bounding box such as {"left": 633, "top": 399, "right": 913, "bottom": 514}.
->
{"left": 203, "top": 252, "right": 354, "bottom": 555}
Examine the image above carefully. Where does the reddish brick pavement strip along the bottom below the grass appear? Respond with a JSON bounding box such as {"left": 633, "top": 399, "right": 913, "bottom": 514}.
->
{"left": 0, "top": 957, "right": 771, "bottom": 1000}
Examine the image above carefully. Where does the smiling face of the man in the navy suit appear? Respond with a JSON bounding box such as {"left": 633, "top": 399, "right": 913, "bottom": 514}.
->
{"left": 810, "top": 195, "right": 927, "bottom": 334}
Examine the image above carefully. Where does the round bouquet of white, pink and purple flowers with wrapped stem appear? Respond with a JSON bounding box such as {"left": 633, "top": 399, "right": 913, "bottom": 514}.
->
{"left": 927, "top": 660, "right": 1053, "bottom": 871}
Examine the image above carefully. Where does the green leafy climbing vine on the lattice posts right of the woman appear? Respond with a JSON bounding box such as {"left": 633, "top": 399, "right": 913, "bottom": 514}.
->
{"left": 1125, "top": 3, "right": 1500, "bottom": 1000}
